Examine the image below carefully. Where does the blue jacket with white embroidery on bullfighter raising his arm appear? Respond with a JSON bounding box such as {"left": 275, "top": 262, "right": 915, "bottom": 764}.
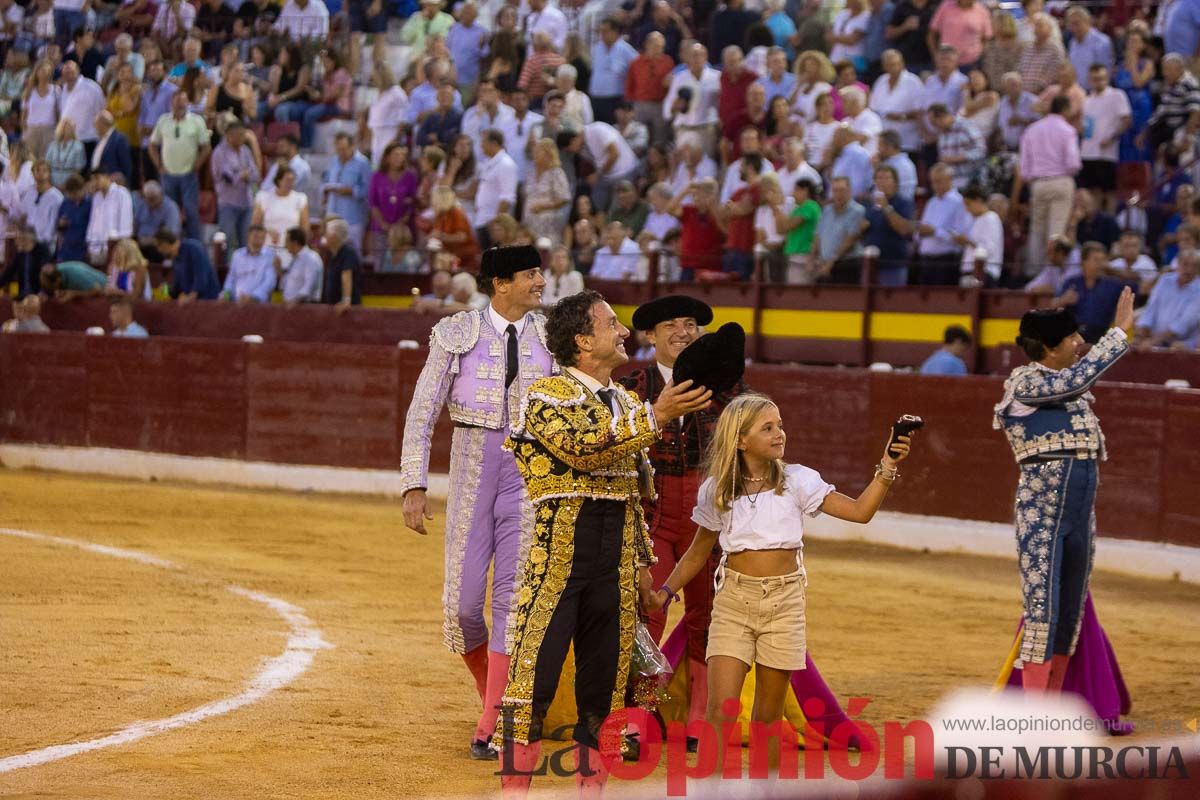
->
{"left": 992, "top": 327, "right": 1129, "bottom": 462}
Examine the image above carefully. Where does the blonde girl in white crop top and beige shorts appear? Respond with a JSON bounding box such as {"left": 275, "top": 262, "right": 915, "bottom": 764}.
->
{"left": 642, "top": 392, "right": 910, "bottom": 753}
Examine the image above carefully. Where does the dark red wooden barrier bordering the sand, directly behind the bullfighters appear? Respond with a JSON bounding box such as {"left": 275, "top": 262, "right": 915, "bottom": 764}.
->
{"left": 0, "top": 333, "right": 1200, "bottom": 546}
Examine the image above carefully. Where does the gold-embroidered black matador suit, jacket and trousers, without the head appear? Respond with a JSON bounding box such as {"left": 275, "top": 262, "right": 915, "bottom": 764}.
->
{"left": 504, "top": 371, "right": 659, "bottom": 747}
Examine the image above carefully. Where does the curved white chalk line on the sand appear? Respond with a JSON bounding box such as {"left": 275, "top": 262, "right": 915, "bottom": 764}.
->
{"left": 0, "top": 528, "right": 334, "bottom": 774}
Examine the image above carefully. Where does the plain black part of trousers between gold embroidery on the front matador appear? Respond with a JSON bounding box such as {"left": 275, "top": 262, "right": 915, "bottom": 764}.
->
{"left": 529, "top": 499, "right": 626, "bottom": 748}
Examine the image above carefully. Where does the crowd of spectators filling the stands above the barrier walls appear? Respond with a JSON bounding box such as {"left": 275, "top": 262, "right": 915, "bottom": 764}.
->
{"left": 0, "top": 0, "right": 1200, "bottom": 348}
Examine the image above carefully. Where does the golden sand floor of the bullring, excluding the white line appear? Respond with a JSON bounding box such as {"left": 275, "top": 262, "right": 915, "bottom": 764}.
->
{"left": 0, "top": 470, "right": 1200, "bottom": 800}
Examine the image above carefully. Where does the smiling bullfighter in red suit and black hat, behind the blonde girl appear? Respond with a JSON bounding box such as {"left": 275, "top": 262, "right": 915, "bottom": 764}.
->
{"left": 620, "top": 295, "right": 744, "bottom": 722}
